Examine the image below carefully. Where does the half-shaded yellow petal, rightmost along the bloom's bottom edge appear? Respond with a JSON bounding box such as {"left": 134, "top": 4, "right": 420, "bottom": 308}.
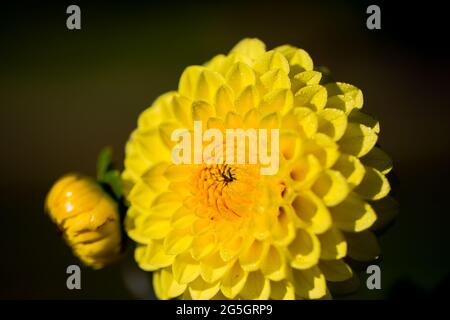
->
{"left": 292, "top": 266, "right": 327, "bottom": 299}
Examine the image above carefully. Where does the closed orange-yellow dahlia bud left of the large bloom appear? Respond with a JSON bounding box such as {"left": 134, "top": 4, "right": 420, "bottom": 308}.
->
{"left": 45, "top": 174, "right": 122, "bottom": 269}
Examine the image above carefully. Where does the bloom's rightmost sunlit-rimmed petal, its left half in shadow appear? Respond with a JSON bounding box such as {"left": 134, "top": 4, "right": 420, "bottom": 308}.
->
{"left": 354, "top": 167, "right": 391, "bottom": 200}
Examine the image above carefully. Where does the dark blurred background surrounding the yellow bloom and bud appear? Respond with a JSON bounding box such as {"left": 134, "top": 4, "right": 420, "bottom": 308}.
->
{"left": 0, "top": 0, "right": 450, "bottom": 299}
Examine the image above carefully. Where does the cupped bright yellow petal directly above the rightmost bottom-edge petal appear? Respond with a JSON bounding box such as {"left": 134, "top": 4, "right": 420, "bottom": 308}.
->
{"left": 288, "top": 229, "right": 320, "bottom": 270}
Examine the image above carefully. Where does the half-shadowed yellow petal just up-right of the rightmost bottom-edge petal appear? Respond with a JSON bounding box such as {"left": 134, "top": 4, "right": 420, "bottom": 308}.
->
{"left": 317, "top": 228, "right": 347, "bottom": 260}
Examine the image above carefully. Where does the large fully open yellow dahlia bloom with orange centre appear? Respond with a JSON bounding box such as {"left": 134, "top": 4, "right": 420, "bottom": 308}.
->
{"left": 122, "top": 39, "right": 393, "bottom": 299}
